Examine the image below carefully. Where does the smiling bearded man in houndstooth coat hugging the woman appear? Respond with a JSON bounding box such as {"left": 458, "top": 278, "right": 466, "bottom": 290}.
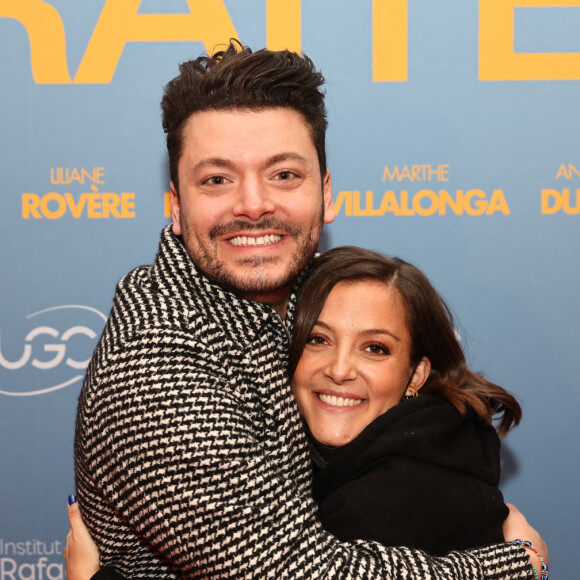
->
{"left": 75, "top": 39, "right": 531, "bottom": 579}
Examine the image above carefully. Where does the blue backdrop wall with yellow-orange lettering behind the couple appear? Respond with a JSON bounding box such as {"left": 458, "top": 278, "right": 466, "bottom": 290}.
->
{"left": 0, "top": 0, "right": 580, "bottom": 580}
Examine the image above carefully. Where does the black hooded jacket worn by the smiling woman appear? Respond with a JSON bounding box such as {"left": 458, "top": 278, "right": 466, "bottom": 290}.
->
{"left": 313, "top": 394, "right": 508, "bottom": 555}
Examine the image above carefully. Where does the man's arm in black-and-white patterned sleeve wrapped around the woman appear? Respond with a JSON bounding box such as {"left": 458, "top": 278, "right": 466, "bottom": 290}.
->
{"left": 76, "top": 329, "right": 533, "bottom": 580}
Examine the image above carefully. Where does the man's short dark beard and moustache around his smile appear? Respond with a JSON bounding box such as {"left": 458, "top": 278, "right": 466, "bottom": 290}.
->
{"left": 180, "top": 213, "right": 323, "bottom": 296}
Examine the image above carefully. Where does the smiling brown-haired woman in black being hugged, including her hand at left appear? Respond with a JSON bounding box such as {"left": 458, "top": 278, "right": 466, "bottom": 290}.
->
{"left": 67, "top": 247, "right": 543, "bottom": 580}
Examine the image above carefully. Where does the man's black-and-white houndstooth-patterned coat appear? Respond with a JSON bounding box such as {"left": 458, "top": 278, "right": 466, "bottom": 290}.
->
{"left": 75, "top": 227, "right": 533, "bottom": 580}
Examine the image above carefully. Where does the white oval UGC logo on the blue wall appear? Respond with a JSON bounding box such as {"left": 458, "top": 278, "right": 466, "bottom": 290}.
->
{"left": 0, "top": 304, "right": 107, "bottom": 397}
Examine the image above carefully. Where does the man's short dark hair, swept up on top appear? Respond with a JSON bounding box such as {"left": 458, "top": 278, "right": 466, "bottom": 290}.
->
{"left": 161, "top": 40, "right": 327, "bottom": 191}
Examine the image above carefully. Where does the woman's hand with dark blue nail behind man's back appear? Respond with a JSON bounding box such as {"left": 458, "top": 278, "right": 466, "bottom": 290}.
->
{"left": 63, "top": 496, "right": 100, "bottom": 580}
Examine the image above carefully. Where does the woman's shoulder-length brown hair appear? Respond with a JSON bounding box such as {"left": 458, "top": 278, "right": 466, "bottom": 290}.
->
{"left": 290, "top": 246, "right": 522, "bottom": 437}
